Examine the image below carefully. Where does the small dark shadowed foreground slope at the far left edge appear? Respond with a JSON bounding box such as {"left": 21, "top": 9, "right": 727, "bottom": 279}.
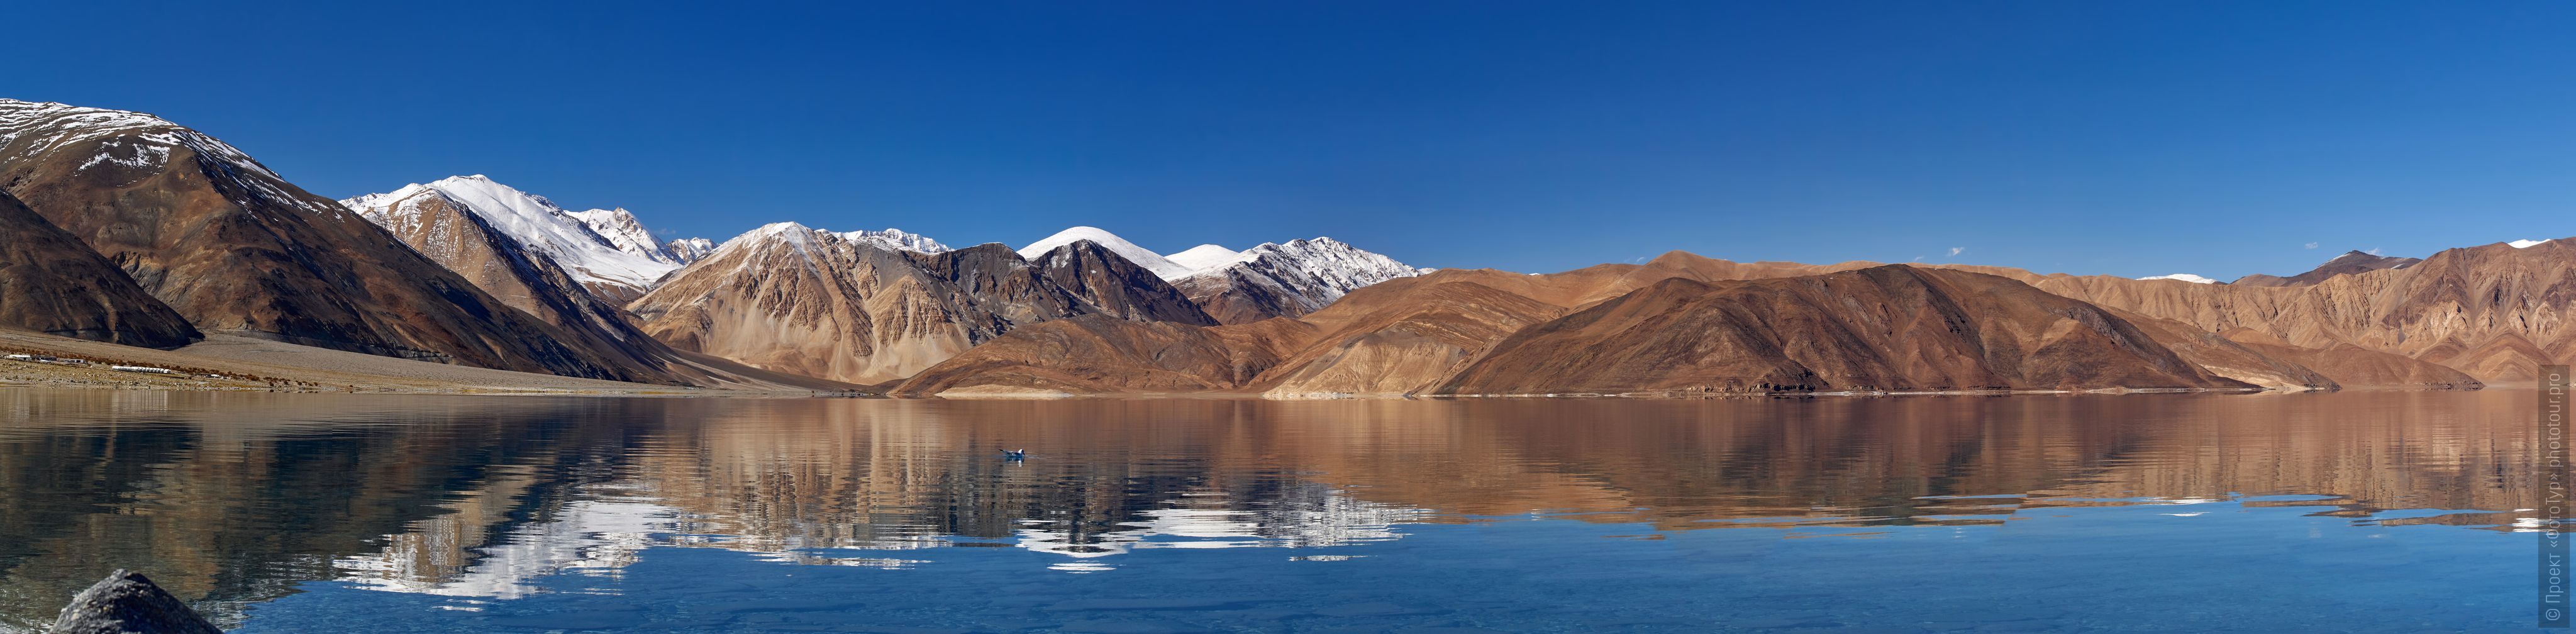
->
{"left": 0, "top": 191, "right": 201, "bottom": 348}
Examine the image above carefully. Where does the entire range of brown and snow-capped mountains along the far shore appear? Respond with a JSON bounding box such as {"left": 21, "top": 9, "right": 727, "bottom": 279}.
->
{"left": 0, "top": 101, "right": 2576, "bottom": 397}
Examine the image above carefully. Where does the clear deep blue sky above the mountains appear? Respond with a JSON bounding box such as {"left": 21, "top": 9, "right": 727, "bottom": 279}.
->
{"left": 0, "top": 3, "right": 2576, "bottom": 279}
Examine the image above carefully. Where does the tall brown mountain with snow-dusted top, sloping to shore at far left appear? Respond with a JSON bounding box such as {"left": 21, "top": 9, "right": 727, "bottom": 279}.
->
{"left": 0, "top": 101, "right": 670, "bottom": 381}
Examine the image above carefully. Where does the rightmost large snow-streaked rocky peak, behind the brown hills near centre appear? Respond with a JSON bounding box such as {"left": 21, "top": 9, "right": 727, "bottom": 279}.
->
{"left": 1167, "top": 237, "right": 1430, "bottom": 325}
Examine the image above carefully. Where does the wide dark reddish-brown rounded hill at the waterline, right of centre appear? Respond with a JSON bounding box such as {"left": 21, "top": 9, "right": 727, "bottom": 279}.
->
{"left": 1435, "top": 265, "right": 2249, "bottom": 394}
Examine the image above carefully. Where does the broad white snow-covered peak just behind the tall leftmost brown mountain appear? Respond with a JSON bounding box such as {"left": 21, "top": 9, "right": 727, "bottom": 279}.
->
{"left": 340, "top": 175, "right": 680, "bottom": 291}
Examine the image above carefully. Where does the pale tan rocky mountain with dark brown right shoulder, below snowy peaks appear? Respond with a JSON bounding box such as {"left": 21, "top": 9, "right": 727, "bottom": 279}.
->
{"left": 628, "top": 221, "right": 1213, "bottom": 384}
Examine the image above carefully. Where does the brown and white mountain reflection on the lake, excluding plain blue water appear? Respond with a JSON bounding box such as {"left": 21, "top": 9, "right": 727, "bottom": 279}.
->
{"left": 0, "top": 389, "right": 2538, "bottom": 631}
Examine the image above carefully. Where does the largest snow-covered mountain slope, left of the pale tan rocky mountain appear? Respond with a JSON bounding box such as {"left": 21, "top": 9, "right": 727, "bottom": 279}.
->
{"left": 340, "top": 175, "right": 680, "bottom": 299}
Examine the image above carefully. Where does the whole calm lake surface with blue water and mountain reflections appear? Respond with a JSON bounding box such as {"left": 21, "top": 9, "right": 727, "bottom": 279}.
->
{"left": 0, "top": 389, "right": 2540, "bottom": 631}
